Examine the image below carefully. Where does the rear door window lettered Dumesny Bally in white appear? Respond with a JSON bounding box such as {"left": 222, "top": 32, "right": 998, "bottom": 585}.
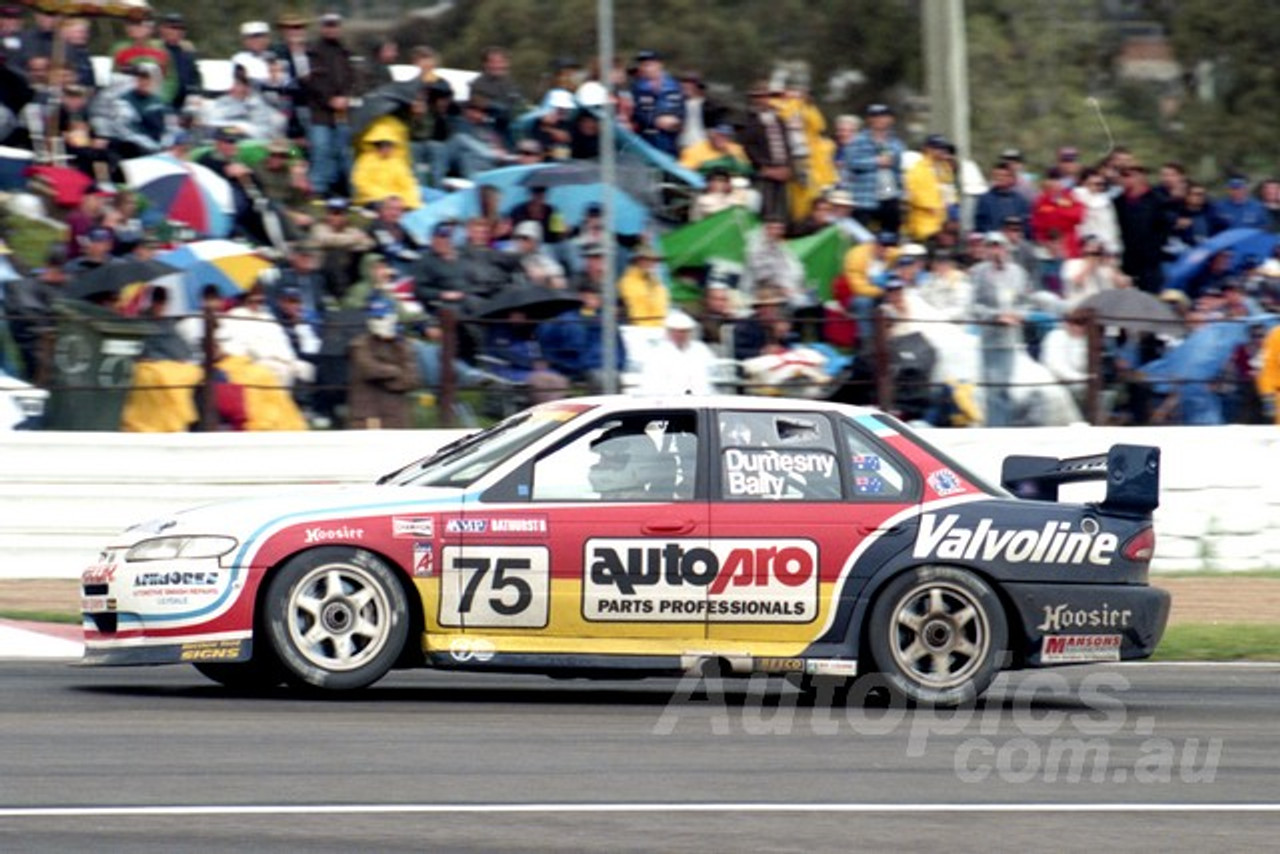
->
{"left": 717, "top": 410, "right": 841, "bottom": 501}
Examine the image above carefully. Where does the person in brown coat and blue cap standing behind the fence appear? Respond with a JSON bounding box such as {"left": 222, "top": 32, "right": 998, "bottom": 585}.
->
{"left": 347, "top": 298, "right": 419, "bottom": 430}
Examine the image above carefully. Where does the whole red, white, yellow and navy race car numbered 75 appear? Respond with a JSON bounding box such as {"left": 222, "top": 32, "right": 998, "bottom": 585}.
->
{"left": 83, "top": 397, "right": 1170, "bottom": 705}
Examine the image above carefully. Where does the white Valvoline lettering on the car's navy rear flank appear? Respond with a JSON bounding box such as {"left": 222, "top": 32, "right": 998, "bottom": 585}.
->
{"left": 911, "top": 513, "right": 1120, "bottom": 566}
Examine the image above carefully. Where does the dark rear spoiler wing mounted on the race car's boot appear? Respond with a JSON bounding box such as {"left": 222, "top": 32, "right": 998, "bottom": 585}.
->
{"left": 1000, "top": 444, "right": 1160, "bottom": 513}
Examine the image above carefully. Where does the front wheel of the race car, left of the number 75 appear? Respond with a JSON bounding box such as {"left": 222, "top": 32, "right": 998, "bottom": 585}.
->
{"left": 265, "top": 547, "right": 410, "bottom": 691}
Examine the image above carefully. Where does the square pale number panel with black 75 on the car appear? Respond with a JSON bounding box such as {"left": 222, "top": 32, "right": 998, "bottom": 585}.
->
{"left": 440, "top": 545, "right": 550, "bottom": 629}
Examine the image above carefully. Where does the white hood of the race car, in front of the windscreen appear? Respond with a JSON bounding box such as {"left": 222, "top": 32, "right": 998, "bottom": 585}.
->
{"left": 115, "top": 485, "right": 463, "bottom": 545}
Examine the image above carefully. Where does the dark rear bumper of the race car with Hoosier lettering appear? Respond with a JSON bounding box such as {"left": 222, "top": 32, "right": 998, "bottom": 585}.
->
{"left": 1004, "top": 584, "right": 1170, "bottom": 667}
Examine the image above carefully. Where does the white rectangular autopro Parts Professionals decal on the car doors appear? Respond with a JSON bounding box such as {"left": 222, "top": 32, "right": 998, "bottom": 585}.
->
{"left": 582, "top": 539, "right": 818, "bottom": 622}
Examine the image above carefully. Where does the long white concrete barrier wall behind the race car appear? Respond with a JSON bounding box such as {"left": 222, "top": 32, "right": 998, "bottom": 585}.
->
{"left": 0, "top": 426, "right": 1280, "bottom": 579}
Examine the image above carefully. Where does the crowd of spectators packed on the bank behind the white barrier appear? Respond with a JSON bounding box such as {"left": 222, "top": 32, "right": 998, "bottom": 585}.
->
{"left": 0, "top": 6, "right": 1280, "bottom": 429}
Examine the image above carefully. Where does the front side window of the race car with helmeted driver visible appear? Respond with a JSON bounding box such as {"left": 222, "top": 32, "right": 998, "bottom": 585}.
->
{"left": 532, "top": 412, "right": 698, "bottom": 502}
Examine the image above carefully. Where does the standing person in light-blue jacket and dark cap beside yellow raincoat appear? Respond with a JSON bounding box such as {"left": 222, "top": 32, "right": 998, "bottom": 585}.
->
{"left": 845, "top": 104, "right": 906, "bottom": 233}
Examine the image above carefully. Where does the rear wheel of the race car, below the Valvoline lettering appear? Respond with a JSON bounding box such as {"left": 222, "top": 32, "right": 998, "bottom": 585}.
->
{"left": 868, "top": 566, "right": 1009, "bottom": 707}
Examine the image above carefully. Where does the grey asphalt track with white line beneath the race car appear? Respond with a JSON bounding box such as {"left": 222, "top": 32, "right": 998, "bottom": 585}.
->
{"left": 0, "top": 661, "right": 1280, "bottom": 851}
